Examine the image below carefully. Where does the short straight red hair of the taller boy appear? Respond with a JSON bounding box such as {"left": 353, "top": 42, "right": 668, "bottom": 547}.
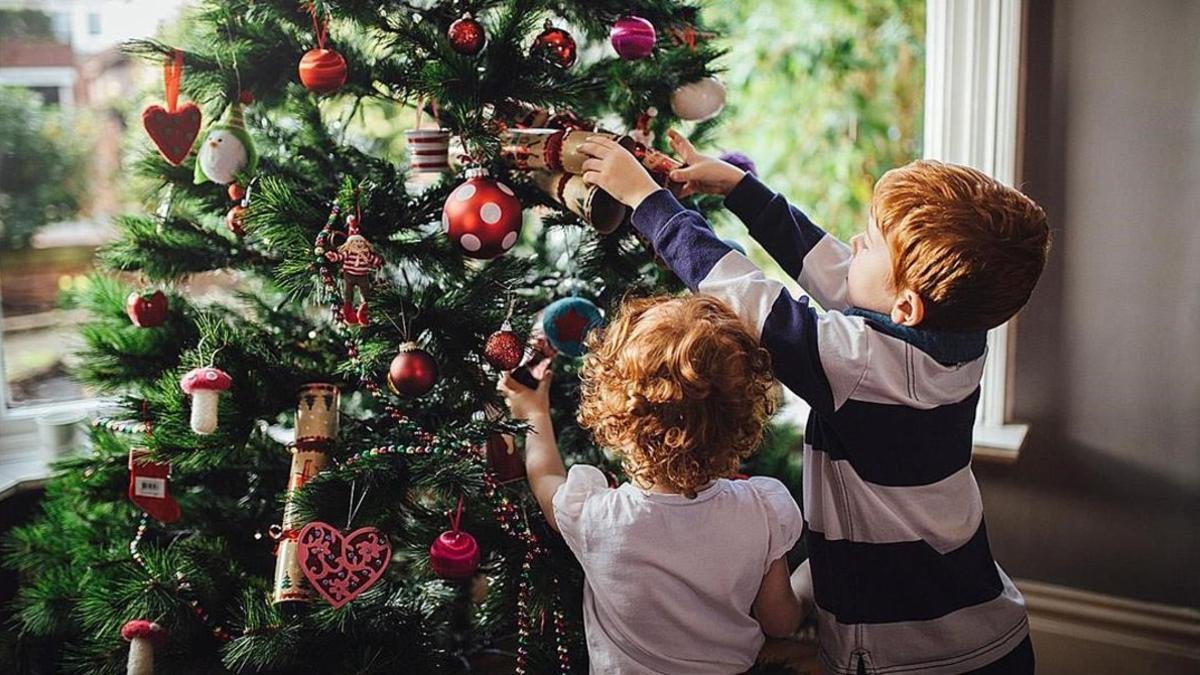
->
{"left": 871, "top": 160, "right": 1050, "bottom": 330}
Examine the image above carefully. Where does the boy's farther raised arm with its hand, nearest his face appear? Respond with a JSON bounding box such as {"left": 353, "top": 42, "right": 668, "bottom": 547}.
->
{"left": 668, "top": 130, "right": 851, "bottom": 310}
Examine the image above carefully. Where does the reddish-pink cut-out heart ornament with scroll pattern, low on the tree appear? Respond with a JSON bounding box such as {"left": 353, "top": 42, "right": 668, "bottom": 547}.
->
{"left": 296, "top": 520, "right": 391, "bottom": 608}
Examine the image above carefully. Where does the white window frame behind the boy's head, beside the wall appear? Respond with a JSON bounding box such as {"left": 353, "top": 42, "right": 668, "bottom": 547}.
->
{"left": 924, "top": 0, "right": 1030, "bottom": 462}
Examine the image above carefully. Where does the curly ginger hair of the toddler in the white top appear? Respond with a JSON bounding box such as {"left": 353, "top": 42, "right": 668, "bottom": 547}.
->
{"left": 578, "top": 294, "right": 775, "bottom": 497}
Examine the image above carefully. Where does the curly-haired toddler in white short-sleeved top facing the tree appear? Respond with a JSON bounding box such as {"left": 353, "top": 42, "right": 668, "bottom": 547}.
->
{"left": 499, "top": 294, "right": 803, "bottom": 675}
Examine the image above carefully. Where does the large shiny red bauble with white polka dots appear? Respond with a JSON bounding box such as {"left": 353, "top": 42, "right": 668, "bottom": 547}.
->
{"left": 442, "top": 168, "right": 522, "bottom": 261}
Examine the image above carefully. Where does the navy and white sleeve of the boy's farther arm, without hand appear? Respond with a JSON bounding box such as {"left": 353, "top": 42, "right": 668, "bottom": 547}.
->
{"left": 725, "top": 173, "right": 851, "bottom": 310}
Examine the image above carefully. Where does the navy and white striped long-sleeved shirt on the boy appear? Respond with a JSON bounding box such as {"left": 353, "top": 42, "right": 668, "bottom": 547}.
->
{"left": 634, "top": 175, "right": 1028, "bottom": 675}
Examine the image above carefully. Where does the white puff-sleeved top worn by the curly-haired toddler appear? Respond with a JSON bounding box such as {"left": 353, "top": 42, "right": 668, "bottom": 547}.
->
{"left": 554, "top": 464, "right": 804, "bottom": 675}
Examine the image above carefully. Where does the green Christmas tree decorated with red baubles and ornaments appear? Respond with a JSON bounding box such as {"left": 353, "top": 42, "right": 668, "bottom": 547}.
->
{"left": 0, "top": 0, "right": 794, "bottom": 674}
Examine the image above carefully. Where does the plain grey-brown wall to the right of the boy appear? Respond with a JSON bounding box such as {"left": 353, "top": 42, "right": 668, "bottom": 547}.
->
{"left": 976, "top": 0, "right": 1200, "bottom": 608}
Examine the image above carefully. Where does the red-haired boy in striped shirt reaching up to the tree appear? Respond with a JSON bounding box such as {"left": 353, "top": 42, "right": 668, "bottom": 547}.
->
{"left": 582, "top": 132, "right": 1049, "bottom": 675}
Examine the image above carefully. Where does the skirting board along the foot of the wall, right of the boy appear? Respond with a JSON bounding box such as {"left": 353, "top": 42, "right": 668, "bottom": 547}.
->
{"left": 1016, "top": 579, "right": 1200, "bottom": 675}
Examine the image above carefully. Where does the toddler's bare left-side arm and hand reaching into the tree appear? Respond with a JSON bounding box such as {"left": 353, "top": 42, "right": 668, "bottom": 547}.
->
{"left": 498, "top": 371, "right": 566, "bottom": 532}
